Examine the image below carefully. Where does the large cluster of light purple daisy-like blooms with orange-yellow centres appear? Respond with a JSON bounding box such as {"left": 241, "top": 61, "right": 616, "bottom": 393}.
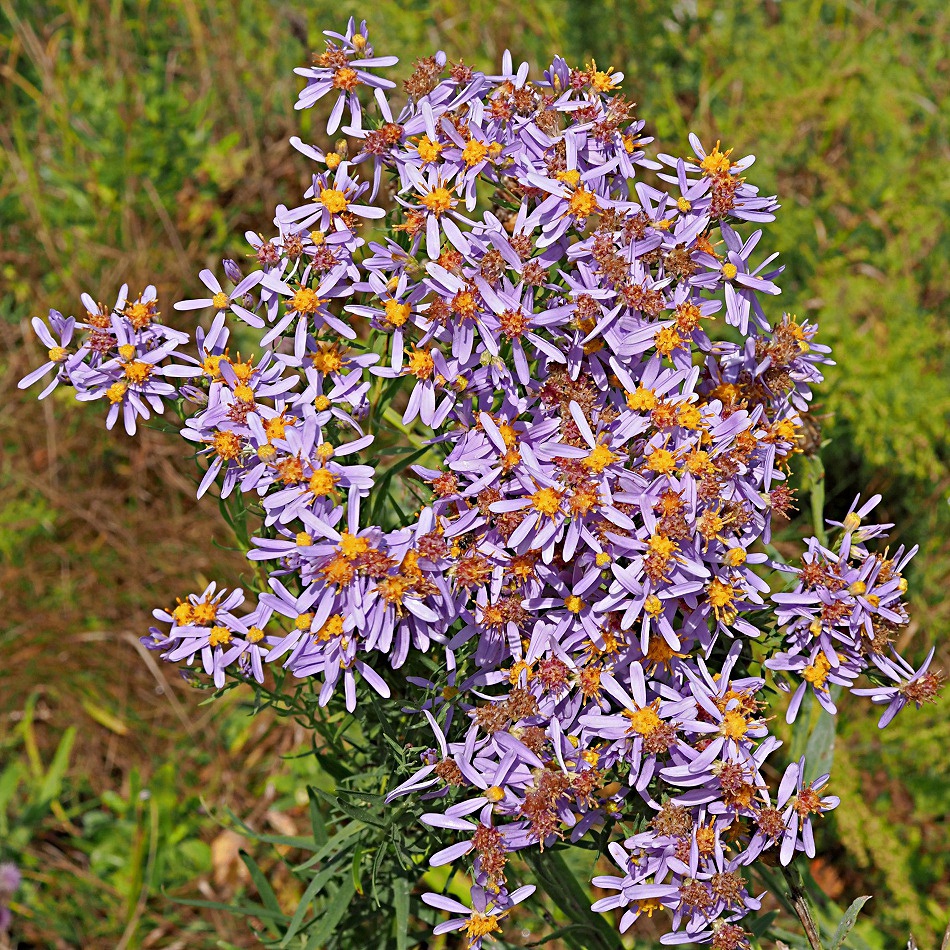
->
{"left": 21, "top": 20, "right": 941, "bottom": 950}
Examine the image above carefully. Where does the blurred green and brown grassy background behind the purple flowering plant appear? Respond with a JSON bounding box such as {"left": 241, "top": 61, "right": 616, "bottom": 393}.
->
{"left": 0, "top": 0, "right": 950, "bottom": 948}
